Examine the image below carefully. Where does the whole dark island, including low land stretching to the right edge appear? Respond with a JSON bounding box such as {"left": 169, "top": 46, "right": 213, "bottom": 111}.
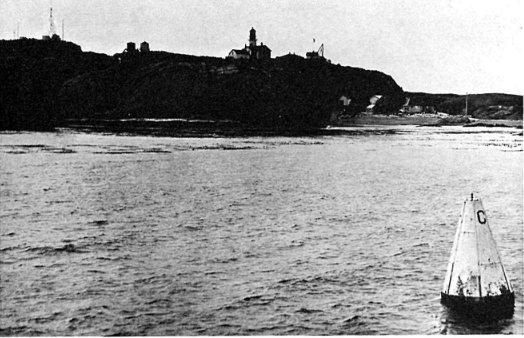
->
{"left": 0, "top": 38, "right": 522, "bottom": 135}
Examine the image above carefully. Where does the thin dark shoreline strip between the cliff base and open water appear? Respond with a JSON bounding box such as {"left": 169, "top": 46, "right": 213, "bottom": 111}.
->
{"left": 2, "top": 117, "right": 523, "bottom": 138}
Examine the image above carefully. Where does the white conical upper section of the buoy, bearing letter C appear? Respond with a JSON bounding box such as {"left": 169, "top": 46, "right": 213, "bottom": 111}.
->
{"left": 442, "top": 194, "right": 513, "bottom": 297}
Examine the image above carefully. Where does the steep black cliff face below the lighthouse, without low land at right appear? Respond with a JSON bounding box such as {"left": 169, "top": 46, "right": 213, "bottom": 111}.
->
{"left": 0, "top": 39, "right": 405, "bottom": 130}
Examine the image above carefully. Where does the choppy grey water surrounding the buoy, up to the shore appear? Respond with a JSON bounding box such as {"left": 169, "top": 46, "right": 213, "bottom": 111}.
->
{"left": 0, "top": 127, "right": 524, "bottom": 335}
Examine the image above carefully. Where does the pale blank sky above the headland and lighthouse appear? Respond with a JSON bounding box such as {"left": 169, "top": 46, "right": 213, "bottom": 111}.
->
{"left": 0, "top": 0, "right": 524, "bottom": 95}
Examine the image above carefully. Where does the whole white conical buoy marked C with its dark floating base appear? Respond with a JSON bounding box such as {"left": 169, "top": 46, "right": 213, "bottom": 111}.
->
{"left": 441, "top": 194, "right": 515, "bottom": 318}
